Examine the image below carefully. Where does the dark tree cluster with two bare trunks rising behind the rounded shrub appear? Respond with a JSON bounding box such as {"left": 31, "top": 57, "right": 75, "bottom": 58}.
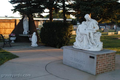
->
{"left": 45, "top": 0, "right": 72, "bottom": 22}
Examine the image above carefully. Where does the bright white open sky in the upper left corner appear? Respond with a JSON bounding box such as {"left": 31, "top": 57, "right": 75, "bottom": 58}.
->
{"left": 0, "top": 0, "right": 20, "bottom": 17}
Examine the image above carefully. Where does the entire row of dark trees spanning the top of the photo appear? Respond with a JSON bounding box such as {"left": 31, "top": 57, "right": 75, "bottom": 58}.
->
{"left": 10, "top": 0, "right": 120, "bottom": 22}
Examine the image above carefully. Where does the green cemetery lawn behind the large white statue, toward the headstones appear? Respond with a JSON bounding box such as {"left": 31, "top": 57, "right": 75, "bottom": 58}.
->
{"left": 69, "top": 33, "right": 120, "bottom": 54}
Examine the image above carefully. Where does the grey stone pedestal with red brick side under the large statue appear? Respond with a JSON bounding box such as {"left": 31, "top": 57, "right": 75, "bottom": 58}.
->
{"left": 63, "top": 46, "right": 115, "bottom": 75}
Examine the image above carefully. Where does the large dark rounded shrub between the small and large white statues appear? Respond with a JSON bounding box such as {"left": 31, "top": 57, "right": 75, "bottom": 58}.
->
{"left": 40, "top": 22, "right": 73, "bottom": 48}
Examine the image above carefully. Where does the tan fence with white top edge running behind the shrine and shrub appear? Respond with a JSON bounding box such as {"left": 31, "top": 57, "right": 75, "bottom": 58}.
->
{"left": 0, "top": 18, "right": 72, "bottom": 38}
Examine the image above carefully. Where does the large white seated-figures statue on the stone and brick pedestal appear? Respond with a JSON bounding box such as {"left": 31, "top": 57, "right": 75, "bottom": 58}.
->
{"left": 73, "top": 14, "right": 103, "bottom": 51}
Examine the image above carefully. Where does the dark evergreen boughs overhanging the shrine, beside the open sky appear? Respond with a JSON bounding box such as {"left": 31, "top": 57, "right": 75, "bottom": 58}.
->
{"left": 10, "top": 0, "right": 45, "bottom": 15}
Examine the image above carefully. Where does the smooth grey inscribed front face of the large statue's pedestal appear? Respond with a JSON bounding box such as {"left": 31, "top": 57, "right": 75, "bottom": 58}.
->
{"left": 63, "top": 49, "right": 96, "bottom": 74}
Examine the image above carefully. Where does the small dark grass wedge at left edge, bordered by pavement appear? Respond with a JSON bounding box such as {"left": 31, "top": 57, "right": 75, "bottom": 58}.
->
{"left": 0, "top": 48, "right": 18, "bottom": 65}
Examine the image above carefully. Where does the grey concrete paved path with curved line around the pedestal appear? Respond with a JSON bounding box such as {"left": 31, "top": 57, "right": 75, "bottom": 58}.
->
{"left": 0, "top": 43, "right": 120, "bottom": 80}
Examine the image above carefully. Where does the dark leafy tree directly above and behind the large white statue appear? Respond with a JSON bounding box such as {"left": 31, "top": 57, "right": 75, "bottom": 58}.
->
{"left": 73, "top": 0, "right": 120, "bottom": 22}
